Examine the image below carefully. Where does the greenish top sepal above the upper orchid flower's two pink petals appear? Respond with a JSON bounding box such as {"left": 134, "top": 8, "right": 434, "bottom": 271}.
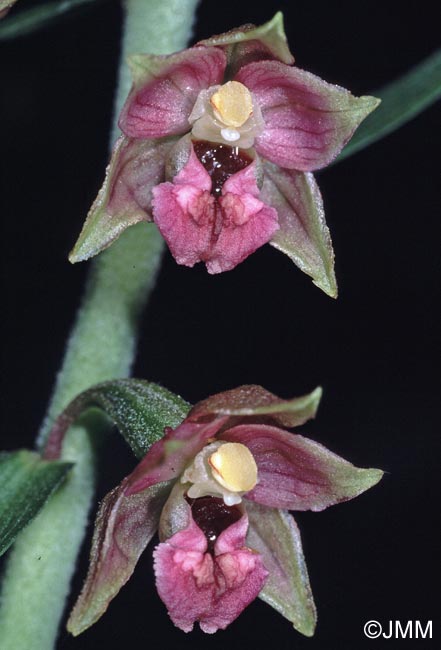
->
{"left": 199, "top": 11, "right": 294, "bottom": 67}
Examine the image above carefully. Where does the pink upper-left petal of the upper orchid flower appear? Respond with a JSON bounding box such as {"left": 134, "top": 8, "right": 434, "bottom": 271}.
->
{"left": 119, "top": 46, "right": 226, "bottom": 138}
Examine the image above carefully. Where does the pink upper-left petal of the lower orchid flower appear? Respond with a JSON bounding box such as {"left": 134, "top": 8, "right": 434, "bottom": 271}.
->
{"left": 126, "top": 417, "right": 227, "bottom": 495}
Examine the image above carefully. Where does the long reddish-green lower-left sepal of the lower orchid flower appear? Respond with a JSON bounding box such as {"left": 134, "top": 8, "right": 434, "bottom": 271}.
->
{"left": 67, "top": 478, "right": 171, "bottom": 636}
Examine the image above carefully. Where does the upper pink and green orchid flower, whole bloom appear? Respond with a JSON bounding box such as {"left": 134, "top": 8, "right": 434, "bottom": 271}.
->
{"left": 70, "top": 13, "right": 379, "bottom": 297}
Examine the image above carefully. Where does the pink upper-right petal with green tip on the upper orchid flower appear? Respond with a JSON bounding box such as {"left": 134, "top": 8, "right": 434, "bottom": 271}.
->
{"left": 235, "top": 61, "right": 379, "bottom": 171}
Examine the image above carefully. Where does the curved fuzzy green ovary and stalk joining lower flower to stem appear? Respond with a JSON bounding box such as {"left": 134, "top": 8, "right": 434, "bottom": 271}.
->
{"left": 45, "top": 379, "right": 190, "bottom": 458}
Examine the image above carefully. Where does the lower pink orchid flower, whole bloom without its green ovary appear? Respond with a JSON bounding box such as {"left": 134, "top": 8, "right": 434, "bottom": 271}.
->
{"left": 68, "top": 386, "right": 382, "bottom": 636}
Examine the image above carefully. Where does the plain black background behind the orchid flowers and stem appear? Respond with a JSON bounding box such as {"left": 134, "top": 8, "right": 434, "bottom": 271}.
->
{"left": 0, "top": 0, "right": 440, "bottom": 650}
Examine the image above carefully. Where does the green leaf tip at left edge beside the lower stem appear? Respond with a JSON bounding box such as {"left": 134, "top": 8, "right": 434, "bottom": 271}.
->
{"left": 0, "top": 449, "right": 73, "bottom": 555}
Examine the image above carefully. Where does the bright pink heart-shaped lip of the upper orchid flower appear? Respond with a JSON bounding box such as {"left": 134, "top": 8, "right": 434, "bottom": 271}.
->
{"left": 153, "top": 149, "right": 278, "bottom": 273}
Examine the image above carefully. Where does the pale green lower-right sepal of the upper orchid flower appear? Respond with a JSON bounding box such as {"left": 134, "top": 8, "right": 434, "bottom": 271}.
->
{"left": 262, "top": 163, "right": 337, "bottom": 298}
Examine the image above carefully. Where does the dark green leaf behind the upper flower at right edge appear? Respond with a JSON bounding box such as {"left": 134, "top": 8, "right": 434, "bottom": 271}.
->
{"left": 335, "top": 50, "right": 441, "bottom": 162}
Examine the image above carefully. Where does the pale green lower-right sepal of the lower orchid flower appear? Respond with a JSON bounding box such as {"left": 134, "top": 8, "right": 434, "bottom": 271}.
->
{"left": 247, "top": 502, "right": 317, "bottom": 636}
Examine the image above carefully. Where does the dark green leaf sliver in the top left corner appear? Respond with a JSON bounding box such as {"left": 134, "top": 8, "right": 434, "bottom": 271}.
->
{"left": 0, "top": 0, "right": 102, "bottom": 41}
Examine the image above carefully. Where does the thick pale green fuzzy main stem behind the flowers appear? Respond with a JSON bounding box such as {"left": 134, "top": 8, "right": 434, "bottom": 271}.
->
{"left": 0, "top": 0, "right": 198, "bottom": 650}
